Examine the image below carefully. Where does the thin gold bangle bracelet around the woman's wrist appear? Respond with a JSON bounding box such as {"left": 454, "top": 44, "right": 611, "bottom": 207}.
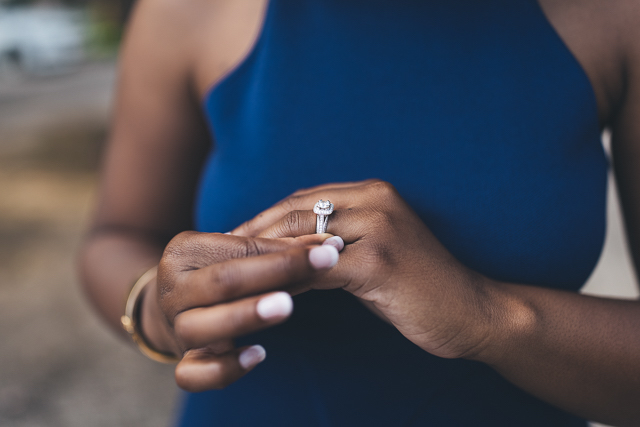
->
{"left": 120, "top": 266, "right": 180, "bottom": 363}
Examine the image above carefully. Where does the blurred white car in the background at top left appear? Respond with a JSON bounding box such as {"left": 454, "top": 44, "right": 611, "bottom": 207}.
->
{"left": 0, "top": 6, "right": 85, "bottom": 76}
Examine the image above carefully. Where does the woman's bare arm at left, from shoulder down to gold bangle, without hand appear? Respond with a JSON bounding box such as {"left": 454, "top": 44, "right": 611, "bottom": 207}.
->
{"left": 80, "top": 1, "right": 209, "bottom": 342}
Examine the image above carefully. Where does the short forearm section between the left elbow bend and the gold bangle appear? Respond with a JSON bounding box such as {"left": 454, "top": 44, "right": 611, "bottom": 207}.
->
{"left": 80, "top": 232, "right": 164, "bottom": 333}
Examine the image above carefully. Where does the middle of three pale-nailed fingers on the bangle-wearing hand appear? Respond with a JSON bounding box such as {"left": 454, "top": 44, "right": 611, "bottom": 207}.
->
{"left": 174, "top": 292, "right": 293, "bottom": 349}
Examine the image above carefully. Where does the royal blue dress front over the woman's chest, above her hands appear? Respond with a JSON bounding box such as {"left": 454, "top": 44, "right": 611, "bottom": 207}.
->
{"left": 198, "top": 1, "right": 607, "bottom": 289}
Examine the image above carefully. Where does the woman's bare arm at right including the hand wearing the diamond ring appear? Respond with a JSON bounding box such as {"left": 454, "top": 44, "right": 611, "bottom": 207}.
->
{"left": 228, "top": 8, "right": 640, "bottom": 425}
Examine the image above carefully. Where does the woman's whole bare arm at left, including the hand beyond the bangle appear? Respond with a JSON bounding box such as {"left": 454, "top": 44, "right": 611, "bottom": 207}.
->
{"left": 80, "top": 0, "right": 328, "bottom": 391}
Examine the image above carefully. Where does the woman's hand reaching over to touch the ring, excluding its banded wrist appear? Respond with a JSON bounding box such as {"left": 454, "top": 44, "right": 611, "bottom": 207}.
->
{"left": 141, "top": 231, "right": 337, "bottom": 392}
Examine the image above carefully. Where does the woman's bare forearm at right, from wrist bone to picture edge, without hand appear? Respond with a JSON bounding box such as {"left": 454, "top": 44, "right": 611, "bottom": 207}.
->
{"left": 476, "top": 281, "right": 640, "bottom": 425}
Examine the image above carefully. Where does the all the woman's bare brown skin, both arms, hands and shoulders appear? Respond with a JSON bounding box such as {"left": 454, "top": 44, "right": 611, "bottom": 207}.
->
{"left": 81, "top": 0, "right": 640, "bottom": 425}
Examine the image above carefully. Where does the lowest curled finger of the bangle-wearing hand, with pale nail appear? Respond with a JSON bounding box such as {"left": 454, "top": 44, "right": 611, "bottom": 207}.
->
{"left": 175, "top": 345, "right": 266, "bottom": 393}
